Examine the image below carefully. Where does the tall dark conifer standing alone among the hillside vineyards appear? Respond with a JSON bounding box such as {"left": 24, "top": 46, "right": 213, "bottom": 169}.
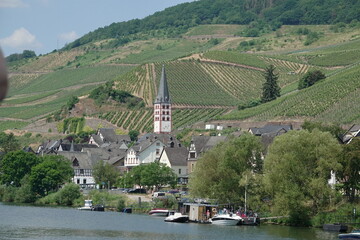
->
{"left": 261, "top": 65, "right": 280, "bottom": 103}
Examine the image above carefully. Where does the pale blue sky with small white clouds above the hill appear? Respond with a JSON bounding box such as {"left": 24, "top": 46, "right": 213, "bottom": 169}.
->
{"left": 0, "top": 0, "right": 194, "bottom": 56}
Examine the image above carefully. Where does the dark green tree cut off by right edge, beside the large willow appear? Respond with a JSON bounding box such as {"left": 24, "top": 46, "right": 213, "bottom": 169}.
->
{"left": 337, "top": 138, "right": 360, "bottom": 202}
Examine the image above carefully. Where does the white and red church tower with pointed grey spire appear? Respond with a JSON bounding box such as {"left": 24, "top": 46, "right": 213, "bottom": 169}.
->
{"left": 154, "top": 65, "right": 172, "bottom": 133}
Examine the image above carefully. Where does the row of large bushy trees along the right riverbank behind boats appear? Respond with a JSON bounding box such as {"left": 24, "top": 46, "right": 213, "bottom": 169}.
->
{"left": 190, "top": 122, "right": 360, "bottom": 225}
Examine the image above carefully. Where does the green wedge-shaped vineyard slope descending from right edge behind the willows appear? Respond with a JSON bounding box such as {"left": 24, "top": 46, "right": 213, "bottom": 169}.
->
{"left": 223, "top": 66, "right": 360, "bottom": 122}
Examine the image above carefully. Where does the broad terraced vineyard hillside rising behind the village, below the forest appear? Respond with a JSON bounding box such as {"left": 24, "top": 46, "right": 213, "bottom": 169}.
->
{"left": 0, "top": 0, "right": 360, "bottom": 135}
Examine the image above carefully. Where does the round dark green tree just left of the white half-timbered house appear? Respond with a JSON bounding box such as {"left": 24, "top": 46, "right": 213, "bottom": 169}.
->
{"left": 29, "top": 155, "right": 74, "bottom": 196}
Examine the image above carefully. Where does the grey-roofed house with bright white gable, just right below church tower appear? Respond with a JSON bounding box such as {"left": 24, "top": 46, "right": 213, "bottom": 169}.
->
{"left": 159, "top": 147, "right": 188, "bottom": 184}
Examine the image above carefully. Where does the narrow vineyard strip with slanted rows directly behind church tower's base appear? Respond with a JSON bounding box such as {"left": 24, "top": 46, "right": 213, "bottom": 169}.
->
{"left": 99, "top": 108, "right": 227, "bottom": 133}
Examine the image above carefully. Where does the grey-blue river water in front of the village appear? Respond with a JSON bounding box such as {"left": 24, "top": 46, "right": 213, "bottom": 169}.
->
{"left": 0, "top": 203, "right": 337, "bottom": 240}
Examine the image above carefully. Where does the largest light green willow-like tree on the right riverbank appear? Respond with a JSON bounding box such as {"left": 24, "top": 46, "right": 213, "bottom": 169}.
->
{"left": 264, "top": 129, "right": 341, "bottom": 225}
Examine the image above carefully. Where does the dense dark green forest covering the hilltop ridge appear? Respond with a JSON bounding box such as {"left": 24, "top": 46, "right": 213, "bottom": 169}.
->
{"left": 65, "top": 0, "right": 360, "bottom": 49}
